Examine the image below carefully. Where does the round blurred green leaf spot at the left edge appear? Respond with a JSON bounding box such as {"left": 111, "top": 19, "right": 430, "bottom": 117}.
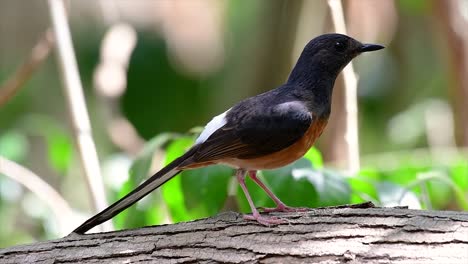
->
{"left": 0, "top": 130, "right": 29, "bottom": 161}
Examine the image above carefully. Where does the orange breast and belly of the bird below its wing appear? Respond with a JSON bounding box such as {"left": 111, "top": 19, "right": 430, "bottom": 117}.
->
{"left": 221, "top": 118, "right": 328, "bottom": 170}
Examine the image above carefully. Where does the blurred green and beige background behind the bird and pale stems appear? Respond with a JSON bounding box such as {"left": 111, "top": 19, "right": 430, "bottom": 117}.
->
{"left": 0, "top": 0, "right": 468, "bottom": 247}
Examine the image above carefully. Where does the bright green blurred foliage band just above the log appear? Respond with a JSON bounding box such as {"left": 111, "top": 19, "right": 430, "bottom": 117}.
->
{"left": 102, "top": 134, "right": 468, "bottom": 228}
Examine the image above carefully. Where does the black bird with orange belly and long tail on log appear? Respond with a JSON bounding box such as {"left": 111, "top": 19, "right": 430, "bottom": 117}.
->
{"left": 72, "top": 33, "right": 384, "bottom": 234}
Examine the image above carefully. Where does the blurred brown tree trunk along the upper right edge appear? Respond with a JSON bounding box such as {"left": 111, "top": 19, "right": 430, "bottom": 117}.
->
{"left": 433, "top": 0, "right": 468, "bottom": 147}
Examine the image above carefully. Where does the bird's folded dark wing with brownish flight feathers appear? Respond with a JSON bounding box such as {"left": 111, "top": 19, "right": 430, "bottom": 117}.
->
{"left": 194, "top": 102, "right": 313, "bottom": 162}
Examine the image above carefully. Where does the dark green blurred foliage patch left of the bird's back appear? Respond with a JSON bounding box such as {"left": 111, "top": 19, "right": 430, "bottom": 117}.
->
{"left": 122, "top": 34, "right": 209, "bottom": 139}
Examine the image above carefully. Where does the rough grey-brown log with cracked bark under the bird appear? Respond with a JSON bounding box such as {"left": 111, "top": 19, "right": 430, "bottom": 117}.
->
{"left": 0, "top": 207, "right": 468, "bottom": 264}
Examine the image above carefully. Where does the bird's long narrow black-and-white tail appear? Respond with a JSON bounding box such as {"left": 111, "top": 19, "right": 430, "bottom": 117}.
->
{"left": 72, "top": 149, "right": 193, "bottom": 234}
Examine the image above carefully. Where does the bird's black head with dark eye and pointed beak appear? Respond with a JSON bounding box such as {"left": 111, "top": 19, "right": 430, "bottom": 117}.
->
{"left": 289, "top": 34, "right": 384, "bottom": 84}
